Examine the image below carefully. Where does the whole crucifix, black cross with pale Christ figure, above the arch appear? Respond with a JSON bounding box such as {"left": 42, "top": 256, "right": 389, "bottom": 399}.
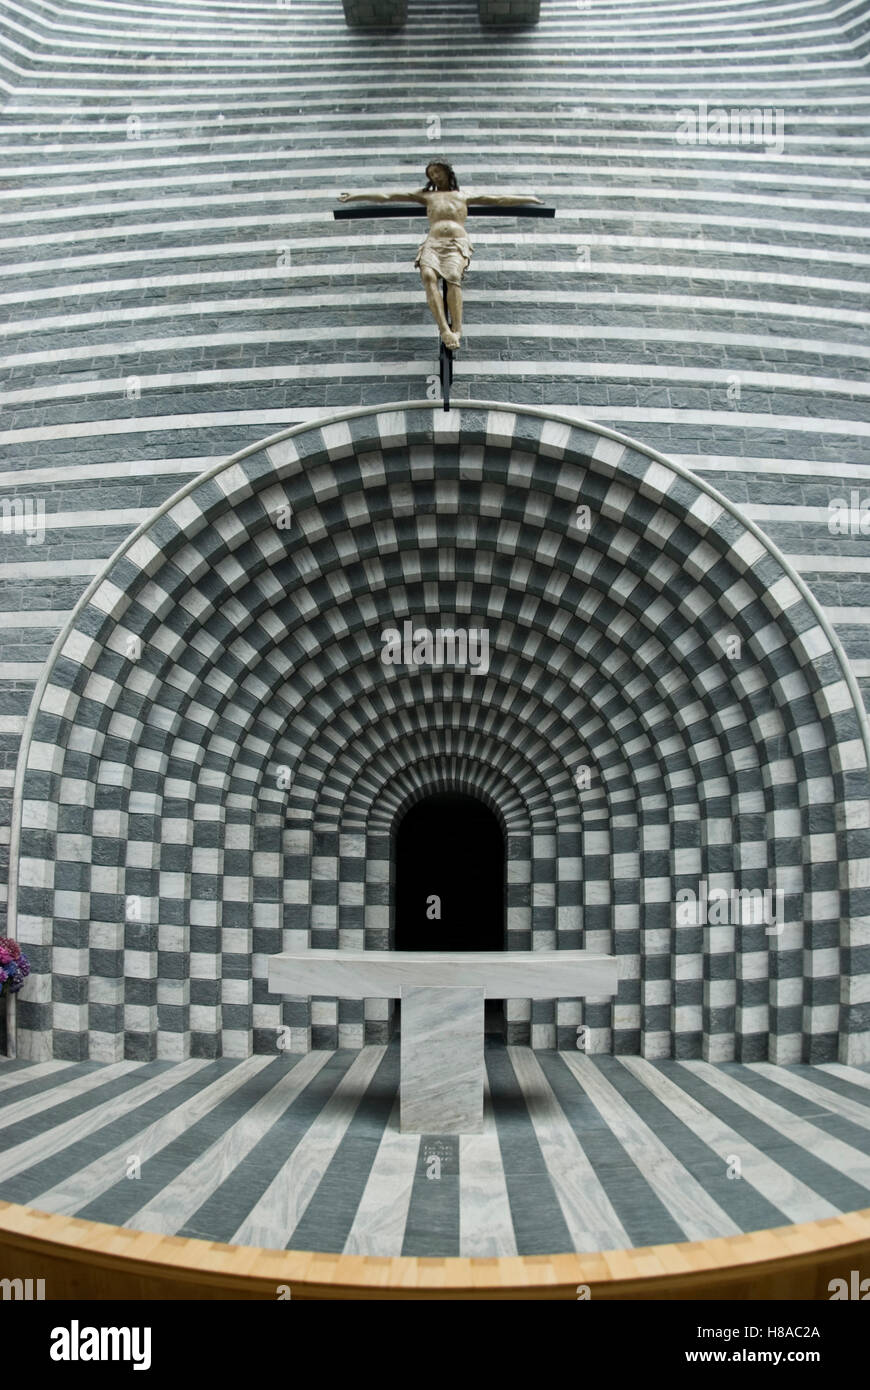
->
{"left": 334, "top": 161, "right": 556, "bottom": 410}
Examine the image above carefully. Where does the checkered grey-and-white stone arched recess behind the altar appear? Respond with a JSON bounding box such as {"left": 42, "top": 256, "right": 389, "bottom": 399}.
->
{"left": 10, "top": 402, "right": 870, "bottom": 1063}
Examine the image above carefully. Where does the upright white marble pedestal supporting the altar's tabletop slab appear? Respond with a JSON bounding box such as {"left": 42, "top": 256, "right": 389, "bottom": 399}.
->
{"left": 400, "top": 986, "right": 485, "bottom": 1134}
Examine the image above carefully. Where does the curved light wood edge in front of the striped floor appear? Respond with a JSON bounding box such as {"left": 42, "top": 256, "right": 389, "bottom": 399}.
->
{"left": 0, "top": 1202, "right": 870, "bottom": 1300}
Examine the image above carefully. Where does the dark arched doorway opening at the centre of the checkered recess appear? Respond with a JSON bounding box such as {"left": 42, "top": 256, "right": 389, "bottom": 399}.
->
{"left": 393, "top": 792, "right": 504, "bottom": 1037}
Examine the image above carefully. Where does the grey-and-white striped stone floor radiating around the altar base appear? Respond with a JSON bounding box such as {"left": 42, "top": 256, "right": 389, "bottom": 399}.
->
{"left": 0, "top": 1040, "right": 870, "bottom": 1257}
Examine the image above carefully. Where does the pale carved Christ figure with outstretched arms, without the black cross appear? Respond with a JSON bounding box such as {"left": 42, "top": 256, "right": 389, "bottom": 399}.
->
{"left": 339, "top": 163, "right": 541, "bottom": 349}
